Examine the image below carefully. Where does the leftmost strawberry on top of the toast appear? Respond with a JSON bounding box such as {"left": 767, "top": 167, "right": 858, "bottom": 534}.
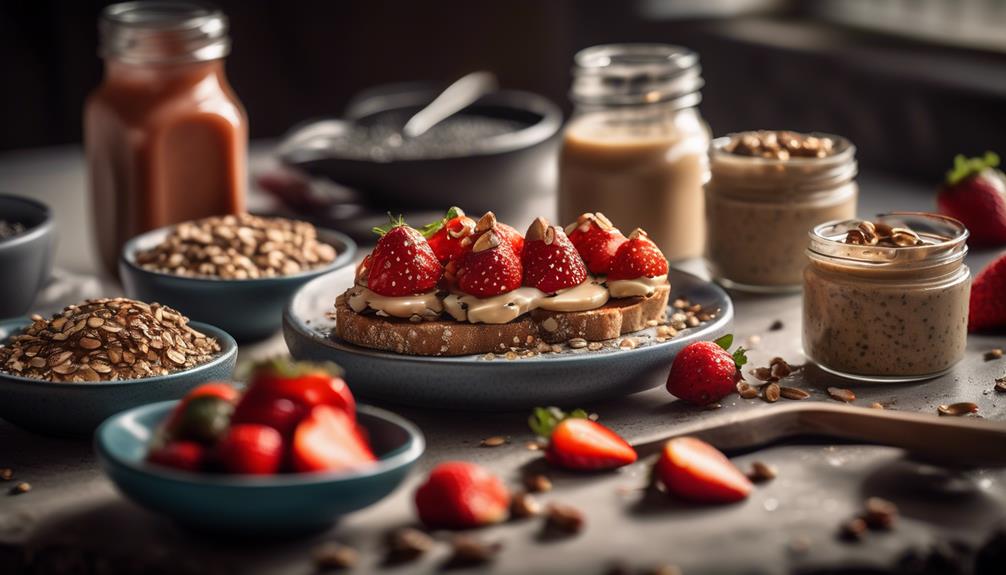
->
{"left": 366, "top": 216, "right": 444, "bottom": 297}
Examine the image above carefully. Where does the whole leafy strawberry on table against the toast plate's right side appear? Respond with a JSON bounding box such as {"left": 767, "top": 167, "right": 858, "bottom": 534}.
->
{"left": 667, "top": 335, "right": 747, "bottom": 405}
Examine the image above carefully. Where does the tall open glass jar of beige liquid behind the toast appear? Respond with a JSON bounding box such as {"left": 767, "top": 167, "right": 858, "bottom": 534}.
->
{"left": 558, "top": 44, "right": 709, "bottom": 260}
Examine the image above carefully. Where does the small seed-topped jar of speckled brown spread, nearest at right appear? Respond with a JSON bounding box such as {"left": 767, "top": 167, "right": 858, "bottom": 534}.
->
{"left": 803, "top": 212, "right": 971, "bottom": 381}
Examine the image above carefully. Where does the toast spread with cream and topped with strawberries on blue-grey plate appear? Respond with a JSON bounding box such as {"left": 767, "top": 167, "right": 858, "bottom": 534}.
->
{"left": 335, "top": 208, "right": 670, "bottom": 356}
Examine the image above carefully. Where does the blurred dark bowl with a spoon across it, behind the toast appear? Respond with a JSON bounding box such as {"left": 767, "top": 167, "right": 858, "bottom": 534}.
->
{"left": 280, "top": 84, "right": 562, "bottom": 221}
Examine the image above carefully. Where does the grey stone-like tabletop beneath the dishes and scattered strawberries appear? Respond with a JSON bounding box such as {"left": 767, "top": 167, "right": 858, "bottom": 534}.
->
{"left": 0, "top": 144, "right": 1006, "bottom": 574}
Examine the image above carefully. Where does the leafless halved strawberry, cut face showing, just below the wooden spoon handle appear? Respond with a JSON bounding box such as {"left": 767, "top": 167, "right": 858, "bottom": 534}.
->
{"left": 656, "top": 437, "right": 751, "bottom": 503}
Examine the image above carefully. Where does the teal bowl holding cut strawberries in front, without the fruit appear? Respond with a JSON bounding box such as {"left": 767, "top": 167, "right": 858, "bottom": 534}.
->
{"left": 95, "top": 401, "right": 426, "bottom": 535}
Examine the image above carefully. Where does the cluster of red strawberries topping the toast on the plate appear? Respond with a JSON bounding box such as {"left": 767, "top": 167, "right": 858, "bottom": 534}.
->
{"left": 356, "top": 207, "right": 667, "bottom": 298}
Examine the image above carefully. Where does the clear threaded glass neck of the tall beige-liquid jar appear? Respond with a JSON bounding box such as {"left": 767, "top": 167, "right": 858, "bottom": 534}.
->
{"left": 570, "top": 44, "right": 703, "bottom": 108}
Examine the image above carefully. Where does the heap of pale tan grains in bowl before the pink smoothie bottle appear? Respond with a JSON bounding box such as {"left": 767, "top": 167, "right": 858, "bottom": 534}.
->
{"left": 136, "top": 214, "right": 336, "bottom": 279}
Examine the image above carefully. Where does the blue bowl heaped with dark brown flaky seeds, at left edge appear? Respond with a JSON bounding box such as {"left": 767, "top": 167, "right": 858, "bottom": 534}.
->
{"left": 0, "top": 298, "right": 237, "bottom": 435}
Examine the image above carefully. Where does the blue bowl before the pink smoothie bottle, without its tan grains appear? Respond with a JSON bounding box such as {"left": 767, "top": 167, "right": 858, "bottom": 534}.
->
{"left": 119, "top": 226, "right": 356, "bottom": 342}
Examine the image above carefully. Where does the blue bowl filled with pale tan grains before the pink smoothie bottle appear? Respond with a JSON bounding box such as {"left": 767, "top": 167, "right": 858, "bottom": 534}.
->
{"left": 119, "top": 214, "right": 356, "bottom": 341}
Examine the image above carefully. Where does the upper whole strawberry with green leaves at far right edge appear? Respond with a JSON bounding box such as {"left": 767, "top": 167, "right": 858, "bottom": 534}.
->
{"left": 937, "top": 152, "right": 1006, "bottom": 246}
